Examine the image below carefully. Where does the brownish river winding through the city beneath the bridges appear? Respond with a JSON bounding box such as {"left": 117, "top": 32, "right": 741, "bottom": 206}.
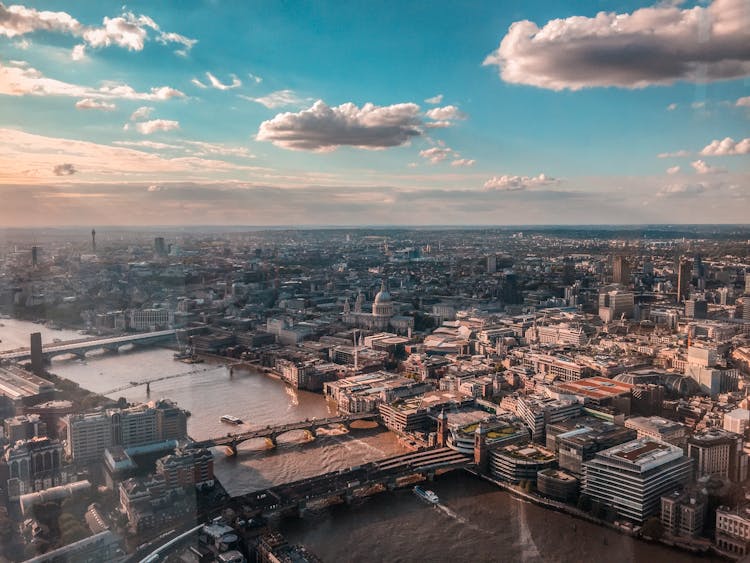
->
{"left": 0, "top": 320, "right": 724, "bottom": 563}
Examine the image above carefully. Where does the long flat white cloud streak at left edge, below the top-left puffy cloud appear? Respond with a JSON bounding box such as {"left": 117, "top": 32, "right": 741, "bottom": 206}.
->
{"left": 0, "top": 62, "right": 185, "bottom": 100}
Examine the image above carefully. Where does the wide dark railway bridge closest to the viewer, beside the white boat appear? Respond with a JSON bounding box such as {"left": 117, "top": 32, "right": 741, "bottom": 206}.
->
{"left": 231, "top": 448, "right": 473, "bottom": 516}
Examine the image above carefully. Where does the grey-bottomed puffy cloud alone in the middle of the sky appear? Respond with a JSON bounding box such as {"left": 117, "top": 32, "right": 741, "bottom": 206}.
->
{"left": 256, "top": 100, "right": 422, "bottom": 151}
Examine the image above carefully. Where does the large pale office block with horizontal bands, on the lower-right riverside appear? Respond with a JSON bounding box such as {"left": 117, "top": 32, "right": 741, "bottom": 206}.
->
{"left": 583, "top": 438, "right": 693, "bottom": 523}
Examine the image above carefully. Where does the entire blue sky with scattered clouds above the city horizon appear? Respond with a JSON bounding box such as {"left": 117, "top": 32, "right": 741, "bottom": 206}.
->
{"left": 0, "top": 0, "right": 750, "bottom": 227}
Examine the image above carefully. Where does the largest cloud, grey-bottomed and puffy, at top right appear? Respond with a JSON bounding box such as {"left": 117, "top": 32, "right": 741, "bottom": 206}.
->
{"left": 484, "top": 0, "right": 750, "bottom": 90}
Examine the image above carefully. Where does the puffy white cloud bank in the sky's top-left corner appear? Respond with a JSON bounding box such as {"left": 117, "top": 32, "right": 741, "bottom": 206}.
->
{"left": 0, "top": 3, "right": 197, "bottom": 54}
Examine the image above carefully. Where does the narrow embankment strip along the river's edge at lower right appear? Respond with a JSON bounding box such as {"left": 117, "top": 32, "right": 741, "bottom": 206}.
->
{"left": 464, "top": 468, "right": 733, "bottom": 561}
